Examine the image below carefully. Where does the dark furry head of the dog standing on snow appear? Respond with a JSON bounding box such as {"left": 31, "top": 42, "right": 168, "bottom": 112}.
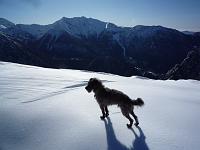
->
{"left": 85, "top": 78, "right": 103, "bottom": 93}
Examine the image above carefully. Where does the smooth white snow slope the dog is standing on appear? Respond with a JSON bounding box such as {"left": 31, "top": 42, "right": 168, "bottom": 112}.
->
{"left": 0, "top": 62, "right": 200, "bottom": 150}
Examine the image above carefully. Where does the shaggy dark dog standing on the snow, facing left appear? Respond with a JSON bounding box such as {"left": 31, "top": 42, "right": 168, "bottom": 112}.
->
{"left": 85, "top": 78, "right": 144, "bottom": 128}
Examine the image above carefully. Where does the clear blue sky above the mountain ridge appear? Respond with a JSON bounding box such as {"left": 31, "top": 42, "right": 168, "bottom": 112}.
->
{"left": 0, "top": 0, "right": 200, "bottom": 31}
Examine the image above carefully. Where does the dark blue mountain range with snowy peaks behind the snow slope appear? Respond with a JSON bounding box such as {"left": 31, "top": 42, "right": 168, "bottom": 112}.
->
{"left": 0, "top": 17, "right": 200, "bottom": 78}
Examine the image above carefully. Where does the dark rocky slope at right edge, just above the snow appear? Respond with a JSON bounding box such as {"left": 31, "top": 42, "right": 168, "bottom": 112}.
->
{"left": 165, "top": 50, "right": 200, "bottom": 80}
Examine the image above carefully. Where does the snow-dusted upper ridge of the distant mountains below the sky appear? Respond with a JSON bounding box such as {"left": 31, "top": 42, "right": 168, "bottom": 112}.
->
{"left": 0, "top": 16, "right": 198, "bottom": 40}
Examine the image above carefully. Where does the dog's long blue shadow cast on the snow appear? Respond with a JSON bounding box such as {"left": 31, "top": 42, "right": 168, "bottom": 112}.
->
{"left": 104, "top": 117, "right": 149, "bottom": 150}
